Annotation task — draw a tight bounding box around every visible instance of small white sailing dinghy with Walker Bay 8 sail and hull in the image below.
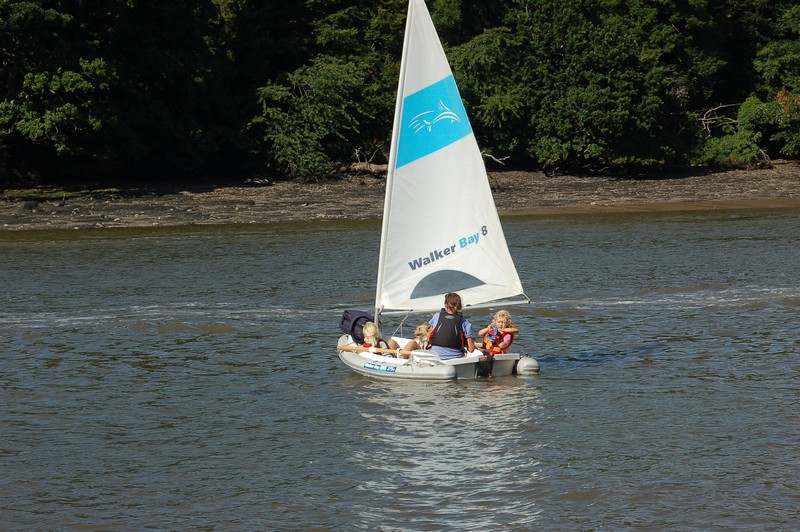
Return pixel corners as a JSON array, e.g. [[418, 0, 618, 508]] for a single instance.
[[337, 0, 538, 380]]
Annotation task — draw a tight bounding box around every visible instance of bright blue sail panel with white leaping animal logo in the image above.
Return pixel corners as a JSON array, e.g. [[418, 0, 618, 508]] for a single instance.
[[396, 75, 472, 168]]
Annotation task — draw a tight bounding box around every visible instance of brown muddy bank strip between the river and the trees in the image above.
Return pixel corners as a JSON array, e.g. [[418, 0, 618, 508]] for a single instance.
[[0, 161, 800, 231]]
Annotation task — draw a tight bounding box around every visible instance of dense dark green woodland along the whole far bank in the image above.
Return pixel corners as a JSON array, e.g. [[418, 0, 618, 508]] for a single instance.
[[0, 0, 800, 182]]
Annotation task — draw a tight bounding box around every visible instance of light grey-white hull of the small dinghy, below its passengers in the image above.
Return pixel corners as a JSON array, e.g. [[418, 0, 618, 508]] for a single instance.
[[337, 334, 539, 381]]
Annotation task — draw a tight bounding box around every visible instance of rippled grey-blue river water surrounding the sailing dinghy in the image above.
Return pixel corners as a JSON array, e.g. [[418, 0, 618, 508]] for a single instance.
[[0, 209, 800, 530]]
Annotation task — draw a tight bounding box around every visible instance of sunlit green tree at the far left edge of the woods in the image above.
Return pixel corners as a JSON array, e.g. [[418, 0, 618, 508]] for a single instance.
[[0, 2, 116, 180]]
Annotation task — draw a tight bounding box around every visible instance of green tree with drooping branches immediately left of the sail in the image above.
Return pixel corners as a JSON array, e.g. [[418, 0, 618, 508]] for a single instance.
[[249, 0, 405, 177]]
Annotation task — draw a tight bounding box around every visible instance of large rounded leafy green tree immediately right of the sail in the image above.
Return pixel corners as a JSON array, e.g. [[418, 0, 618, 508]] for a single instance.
[[453, 0, 688, 166]]
